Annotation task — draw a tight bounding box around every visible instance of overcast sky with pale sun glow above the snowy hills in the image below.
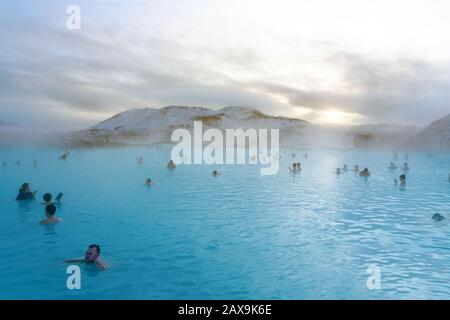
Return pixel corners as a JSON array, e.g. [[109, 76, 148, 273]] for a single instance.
[[0, 0, 450, 129]]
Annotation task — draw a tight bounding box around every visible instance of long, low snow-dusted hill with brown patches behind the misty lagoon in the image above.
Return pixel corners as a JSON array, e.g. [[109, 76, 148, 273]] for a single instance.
[[68, 106, 309, 144]]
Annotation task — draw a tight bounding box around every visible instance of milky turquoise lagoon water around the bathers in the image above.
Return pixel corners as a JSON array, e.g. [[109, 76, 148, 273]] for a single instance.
[[0, 146, 450, 299]]
